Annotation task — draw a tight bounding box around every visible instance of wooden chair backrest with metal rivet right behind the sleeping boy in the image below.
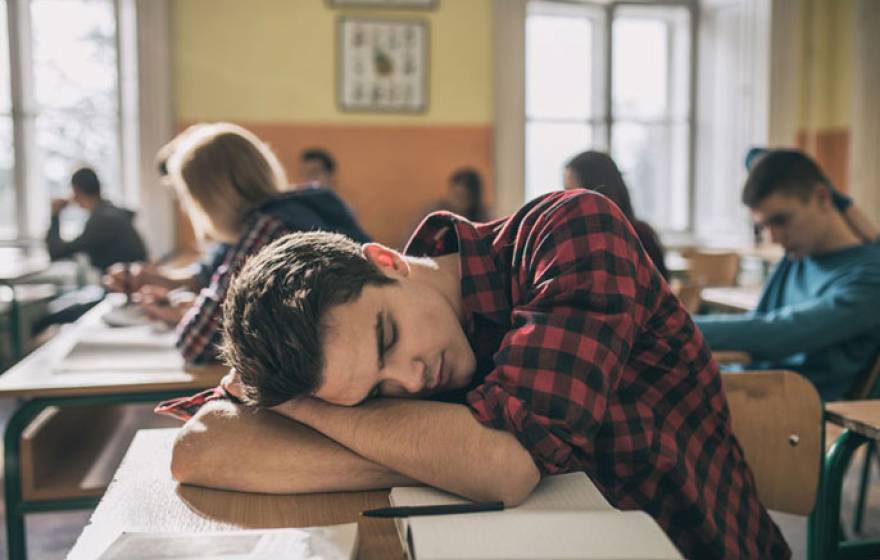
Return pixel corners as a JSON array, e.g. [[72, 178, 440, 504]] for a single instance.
[[721, 371, 823, 515]]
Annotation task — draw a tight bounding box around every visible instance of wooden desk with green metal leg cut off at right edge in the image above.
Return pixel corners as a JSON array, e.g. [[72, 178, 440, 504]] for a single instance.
[[817, 400, 880, 559]]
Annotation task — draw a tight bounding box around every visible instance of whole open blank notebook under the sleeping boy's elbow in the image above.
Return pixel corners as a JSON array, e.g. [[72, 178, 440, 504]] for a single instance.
[[390, 472, 682, 560]]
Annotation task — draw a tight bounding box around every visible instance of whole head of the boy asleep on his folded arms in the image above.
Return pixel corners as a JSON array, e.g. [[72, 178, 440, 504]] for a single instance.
[[223, 232, 475, 406]]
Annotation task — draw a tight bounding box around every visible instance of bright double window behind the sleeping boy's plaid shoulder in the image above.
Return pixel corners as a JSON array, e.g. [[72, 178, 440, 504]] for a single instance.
[[526, 1, 693, 232]]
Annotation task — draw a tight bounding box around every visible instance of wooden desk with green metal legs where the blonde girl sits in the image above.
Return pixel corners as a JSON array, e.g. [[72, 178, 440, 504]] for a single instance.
[[0, 301, 226, 560]]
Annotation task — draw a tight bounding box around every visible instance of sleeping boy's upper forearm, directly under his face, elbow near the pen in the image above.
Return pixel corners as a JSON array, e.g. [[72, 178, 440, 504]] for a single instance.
[[277, 399, 540, 505]]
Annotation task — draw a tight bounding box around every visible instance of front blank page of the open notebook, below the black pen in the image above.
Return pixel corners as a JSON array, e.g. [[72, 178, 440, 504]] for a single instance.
[[409, 510, 682, 560]]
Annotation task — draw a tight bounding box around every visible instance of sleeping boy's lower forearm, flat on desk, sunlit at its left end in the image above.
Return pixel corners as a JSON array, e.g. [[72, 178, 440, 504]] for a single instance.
[[171, 401, 413, 494]]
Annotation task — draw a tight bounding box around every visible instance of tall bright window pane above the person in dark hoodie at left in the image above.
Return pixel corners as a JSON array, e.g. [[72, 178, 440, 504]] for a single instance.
[[31, 0, 122, 221]]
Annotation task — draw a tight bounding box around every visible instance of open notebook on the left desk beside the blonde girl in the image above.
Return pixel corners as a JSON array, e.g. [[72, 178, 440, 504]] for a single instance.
[[54, 326, 184, 372]]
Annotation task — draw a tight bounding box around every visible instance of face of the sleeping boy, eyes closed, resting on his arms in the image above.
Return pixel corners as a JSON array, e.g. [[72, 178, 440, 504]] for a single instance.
[[314, 271, 476, 406]]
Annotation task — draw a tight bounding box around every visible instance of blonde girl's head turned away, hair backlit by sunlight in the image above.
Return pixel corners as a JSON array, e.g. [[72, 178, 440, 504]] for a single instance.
[[167, 123, 287, 242]]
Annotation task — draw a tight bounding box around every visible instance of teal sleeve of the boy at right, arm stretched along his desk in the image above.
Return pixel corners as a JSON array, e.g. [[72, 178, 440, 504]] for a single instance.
[[694, 273, 880, 360]]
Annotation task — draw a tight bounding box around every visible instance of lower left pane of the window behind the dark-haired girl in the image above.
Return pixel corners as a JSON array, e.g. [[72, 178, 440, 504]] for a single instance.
[[526, 121, 593, 200]]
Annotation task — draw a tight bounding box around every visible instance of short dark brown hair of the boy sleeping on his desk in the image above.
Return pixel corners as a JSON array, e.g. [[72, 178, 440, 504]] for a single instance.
[[221, 231, 395, 407]]
